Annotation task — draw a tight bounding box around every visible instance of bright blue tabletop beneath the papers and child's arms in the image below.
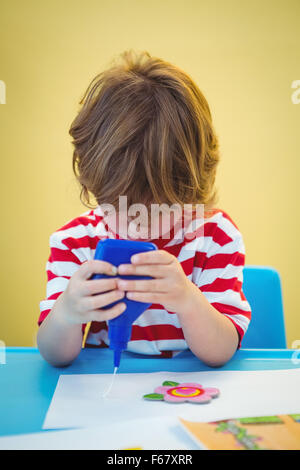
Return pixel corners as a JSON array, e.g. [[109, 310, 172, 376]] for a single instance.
[[0, 348, 300, 435]]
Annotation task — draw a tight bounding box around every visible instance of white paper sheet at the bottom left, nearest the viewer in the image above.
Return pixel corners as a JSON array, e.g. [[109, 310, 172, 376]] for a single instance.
[[0, 417, 199, 450]]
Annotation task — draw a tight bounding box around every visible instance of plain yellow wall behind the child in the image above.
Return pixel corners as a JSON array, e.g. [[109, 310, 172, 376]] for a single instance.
[[0, 0, 300, 346]]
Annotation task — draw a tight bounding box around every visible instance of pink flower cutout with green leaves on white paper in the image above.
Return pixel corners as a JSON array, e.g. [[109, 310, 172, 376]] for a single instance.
[[143, 381, 220, 403]]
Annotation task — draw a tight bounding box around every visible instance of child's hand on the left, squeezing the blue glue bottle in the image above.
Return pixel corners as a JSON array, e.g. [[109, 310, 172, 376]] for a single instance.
[[59, 259, 126, 324]]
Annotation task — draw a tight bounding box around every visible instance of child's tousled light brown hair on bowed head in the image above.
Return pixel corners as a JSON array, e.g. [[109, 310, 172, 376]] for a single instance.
[[69, 49, 219, 209]]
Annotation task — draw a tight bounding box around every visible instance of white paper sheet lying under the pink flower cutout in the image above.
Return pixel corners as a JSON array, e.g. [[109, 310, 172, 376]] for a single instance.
[[43, 369, 300, 432]]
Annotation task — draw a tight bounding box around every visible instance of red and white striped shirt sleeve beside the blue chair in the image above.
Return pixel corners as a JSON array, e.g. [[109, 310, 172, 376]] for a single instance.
[[192, 215, 251, 348]]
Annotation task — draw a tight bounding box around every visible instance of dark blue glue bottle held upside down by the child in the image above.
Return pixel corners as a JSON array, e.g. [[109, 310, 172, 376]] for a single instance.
[[90, 238, 157, 372]]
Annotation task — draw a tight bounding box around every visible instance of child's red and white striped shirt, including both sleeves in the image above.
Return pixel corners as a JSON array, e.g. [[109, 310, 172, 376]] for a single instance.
[[38, 206, 251, 356]]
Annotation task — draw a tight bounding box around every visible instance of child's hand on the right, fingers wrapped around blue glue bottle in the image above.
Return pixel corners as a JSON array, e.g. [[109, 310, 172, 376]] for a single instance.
[[117, 250, 194, 313]]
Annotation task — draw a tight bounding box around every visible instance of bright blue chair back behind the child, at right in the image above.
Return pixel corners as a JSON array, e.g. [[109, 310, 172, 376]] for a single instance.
[[241, 265, 286, 349]]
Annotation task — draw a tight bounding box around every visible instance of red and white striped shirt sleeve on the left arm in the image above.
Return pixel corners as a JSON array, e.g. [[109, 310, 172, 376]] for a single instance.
[[38, 231, 81, 326]]
